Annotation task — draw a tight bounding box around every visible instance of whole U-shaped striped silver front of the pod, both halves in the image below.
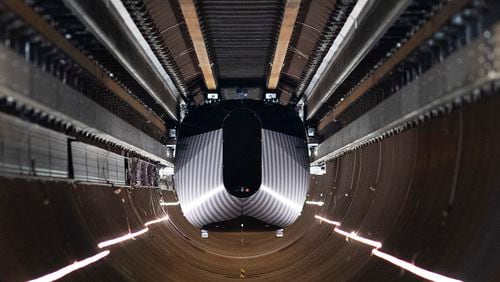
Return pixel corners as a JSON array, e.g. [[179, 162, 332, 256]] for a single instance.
[[175, 129, 309, 227]]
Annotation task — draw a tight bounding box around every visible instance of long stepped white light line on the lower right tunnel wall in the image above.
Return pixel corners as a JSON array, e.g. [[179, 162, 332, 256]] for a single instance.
[[314, 215, 463, 282]]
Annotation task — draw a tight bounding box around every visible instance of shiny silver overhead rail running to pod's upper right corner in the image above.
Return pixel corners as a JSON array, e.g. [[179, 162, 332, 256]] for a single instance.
[[305, 0, 412, 119]]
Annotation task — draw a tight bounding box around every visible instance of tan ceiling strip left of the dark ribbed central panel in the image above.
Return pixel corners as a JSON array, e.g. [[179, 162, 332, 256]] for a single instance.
[[179, 0, 217, 90]]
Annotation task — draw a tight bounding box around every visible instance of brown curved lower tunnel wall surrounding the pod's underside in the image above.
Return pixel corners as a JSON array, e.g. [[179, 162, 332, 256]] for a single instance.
[[0, 97, 500, 281]]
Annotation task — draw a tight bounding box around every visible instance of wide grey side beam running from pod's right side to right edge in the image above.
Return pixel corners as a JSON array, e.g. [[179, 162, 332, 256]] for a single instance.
[[313, 24, 500, 164]]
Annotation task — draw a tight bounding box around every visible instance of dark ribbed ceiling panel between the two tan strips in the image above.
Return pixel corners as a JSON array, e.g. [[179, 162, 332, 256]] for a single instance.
[[197, 0, 283, 87]]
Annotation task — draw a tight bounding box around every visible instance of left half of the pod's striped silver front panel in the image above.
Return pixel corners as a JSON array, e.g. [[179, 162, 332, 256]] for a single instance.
[[175, 129, 241, 227]]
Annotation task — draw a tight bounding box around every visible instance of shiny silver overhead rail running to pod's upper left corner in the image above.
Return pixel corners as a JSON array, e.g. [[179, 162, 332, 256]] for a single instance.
[[63, 0, 179, 120]]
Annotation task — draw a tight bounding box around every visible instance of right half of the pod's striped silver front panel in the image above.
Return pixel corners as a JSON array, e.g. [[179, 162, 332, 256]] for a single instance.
[[243, 129, 309, 226]]
